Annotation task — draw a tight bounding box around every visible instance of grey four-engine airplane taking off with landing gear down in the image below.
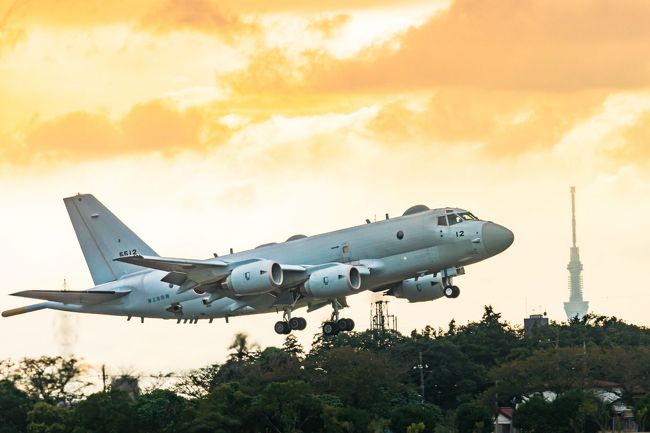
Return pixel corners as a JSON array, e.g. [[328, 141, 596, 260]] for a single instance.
[[2, 194, 514, 336]]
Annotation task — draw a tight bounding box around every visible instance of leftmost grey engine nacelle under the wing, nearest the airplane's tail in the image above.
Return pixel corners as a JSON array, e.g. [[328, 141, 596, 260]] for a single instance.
[[226, 260, 284, 295]]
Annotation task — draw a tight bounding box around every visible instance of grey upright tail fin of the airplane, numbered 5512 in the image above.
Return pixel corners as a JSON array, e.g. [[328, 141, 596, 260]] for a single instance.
[[63, 194, 158, 285]]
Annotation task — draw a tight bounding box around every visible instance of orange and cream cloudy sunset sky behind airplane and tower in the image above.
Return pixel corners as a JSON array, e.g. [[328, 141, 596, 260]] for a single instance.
[[0, 0, 650, 372]]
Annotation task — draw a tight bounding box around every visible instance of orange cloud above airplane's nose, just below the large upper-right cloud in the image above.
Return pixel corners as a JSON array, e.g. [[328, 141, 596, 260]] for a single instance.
[[367, 89, 605, 158]]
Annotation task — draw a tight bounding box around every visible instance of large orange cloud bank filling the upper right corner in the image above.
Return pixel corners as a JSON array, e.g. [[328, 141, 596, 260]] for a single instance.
[[220, 0, 650, 93]]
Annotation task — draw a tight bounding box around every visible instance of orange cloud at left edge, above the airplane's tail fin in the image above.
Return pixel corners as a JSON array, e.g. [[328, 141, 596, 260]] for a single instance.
[[0, 100, 232, 165]]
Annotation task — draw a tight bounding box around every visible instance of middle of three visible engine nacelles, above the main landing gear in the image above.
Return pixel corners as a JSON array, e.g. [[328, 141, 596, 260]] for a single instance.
[[305, 264, 361, 298]]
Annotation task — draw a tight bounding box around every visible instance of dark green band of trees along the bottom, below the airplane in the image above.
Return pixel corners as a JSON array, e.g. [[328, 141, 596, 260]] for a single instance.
[[0, 306, 650, 433]]
